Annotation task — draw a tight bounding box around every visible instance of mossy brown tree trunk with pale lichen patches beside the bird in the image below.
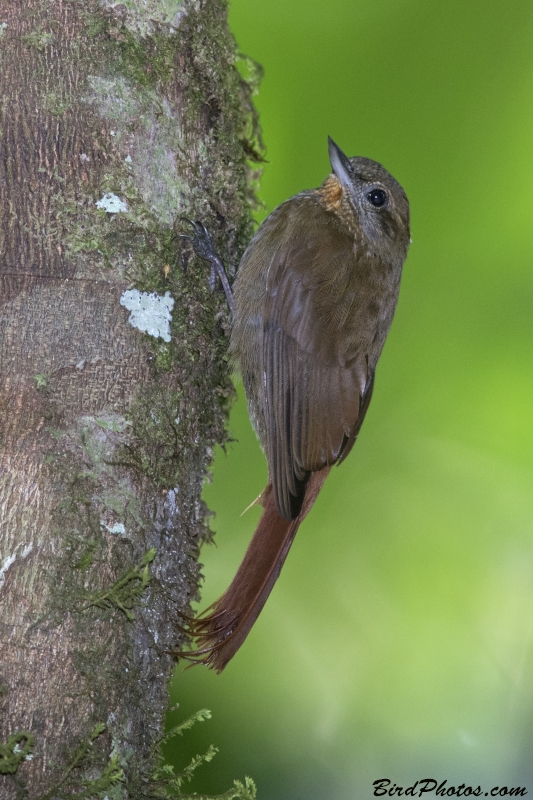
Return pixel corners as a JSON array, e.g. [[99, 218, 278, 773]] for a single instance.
[[0, 0, 257, 800]]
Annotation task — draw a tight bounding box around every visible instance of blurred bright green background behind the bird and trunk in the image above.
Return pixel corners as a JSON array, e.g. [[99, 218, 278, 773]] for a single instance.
[[168, 0, 533, 800]]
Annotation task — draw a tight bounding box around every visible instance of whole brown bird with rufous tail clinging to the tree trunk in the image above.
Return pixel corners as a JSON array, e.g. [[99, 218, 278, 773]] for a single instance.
[[178, 137, 410, 672]]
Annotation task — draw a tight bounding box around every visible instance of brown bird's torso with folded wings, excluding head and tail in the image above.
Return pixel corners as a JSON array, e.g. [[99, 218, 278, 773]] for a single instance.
[[231, 198, 388, 520]]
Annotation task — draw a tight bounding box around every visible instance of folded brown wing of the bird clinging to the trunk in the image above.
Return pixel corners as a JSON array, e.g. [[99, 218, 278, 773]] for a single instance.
[[261, 203, 373, 519]]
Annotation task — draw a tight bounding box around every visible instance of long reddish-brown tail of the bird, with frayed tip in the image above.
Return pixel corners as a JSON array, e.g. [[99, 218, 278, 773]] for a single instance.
[[175, 467, 330, 672]]
